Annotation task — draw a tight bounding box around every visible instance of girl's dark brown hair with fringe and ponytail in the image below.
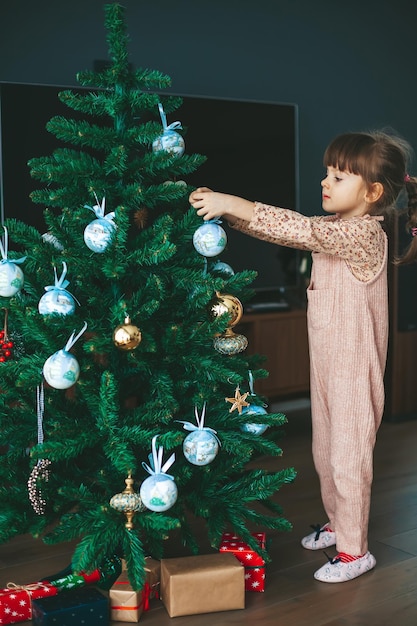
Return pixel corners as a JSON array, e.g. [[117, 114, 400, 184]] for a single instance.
[[323, 131, 417, 264]]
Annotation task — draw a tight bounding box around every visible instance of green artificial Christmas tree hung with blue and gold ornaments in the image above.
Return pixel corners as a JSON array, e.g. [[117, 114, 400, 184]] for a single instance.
[[0, 4, 295, 589]]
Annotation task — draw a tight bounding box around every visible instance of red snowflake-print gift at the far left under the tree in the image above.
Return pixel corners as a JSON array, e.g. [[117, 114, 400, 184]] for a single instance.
[[0, 582, 58, 624]]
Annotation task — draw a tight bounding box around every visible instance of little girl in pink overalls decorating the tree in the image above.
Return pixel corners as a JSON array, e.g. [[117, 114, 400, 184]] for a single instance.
[[190, 132, 417, 583]]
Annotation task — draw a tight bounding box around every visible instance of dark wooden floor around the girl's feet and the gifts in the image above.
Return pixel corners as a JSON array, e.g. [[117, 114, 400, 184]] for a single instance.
[[0, 400, 417, 626]]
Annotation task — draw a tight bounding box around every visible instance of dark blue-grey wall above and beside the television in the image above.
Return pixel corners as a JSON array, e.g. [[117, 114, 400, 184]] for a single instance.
[[0, 0, 417, 214]]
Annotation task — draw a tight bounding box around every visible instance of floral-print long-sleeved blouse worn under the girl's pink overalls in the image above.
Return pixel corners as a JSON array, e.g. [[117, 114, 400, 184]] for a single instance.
[[229, 202, 386, 281]]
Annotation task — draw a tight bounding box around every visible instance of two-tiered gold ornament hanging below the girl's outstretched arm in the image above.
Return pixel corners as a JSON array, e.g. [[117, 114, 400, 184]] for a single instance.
[[211, 291, 248, 356]]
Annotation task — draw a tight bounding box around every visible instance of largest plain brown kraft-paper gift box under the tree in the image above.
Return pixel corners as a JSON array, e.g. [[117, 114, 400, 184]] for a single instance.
[[161, 553, 245, 617]]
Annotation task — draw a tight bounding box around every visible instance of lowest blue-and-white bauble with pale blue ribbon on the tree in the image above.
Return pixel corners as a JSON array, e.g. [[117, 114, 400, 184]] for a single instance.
[[140, 435, 178, 513]]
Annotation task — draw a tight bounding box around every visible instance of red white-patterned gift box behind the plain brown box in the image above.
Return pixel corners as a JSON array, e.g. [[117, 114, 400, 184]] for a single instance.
[[219, 533, 266, 592]]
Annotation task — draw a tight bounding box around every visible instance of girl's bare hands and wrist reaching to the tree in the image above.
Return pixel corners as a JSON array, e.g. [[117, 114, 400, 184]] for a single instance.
[[189, 187, 254, 222]]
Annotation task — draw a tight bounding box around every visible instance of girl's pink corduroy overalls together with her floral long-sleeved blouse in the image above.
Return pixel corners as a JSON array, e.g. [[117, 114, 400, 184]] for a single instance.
[[234, 203, 388, 556]]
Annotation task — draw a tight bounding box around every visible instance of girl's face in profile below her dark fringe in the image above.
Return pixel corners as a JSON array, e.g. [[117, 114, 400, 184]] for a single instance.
[[321, 167, 371, 219]]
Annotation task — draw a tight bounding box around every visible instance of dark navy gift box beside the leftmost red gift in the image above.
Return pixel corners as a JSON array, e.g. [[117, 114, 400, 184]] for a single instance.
[[32, 587, 109, 626]]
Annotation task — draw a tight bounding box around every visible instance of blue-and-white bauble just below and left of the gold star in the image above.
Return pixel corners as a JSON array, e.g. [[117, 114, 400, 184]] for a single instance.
[[178, 405, 220, 465]]
